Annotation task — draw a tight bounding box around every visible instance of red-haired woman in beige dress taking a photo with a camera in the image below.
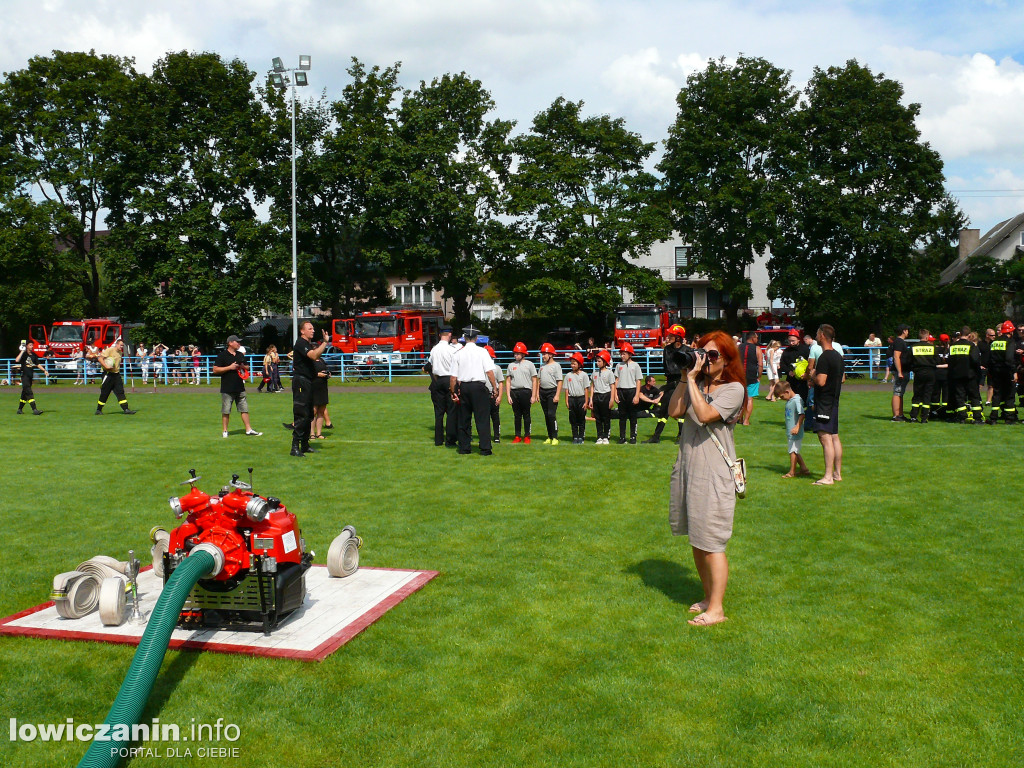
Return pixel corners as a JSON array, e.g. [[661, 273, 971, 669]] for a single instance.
[[669, 331, 746, 627]]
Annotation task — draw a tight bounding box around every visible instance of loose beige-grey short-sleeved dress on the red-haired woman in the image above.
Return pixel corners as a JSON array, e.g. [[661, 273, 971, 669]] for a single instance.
[[669, 380, 744, 552]]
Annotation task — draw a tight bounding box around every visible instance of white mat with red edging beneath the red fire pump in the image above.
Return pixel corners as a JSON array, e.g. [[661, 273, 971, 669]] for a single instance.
[[0, 565, 437, 662]]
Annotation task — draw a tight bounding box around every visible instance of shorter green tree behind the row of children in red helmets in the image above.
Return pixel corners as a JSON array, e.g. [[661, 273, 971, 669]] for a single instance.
[[493, 97, 671, 330]]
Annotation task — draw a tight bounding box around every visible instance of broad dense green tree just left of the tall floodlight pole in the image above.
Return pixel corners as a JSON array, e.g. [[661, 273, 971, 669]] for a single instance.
[[103, 51, 291, 344]]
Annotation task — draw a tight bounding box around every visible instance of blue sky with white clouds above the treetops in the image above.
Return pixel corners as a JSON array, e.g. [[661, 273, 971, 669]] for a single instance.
[[0, 0, 1024, 230]]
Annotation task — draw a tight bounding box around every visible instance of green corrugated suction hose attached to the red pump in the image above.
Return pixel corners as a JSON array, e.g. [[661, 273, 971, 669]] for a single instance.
[[78, 545, 220, 768]]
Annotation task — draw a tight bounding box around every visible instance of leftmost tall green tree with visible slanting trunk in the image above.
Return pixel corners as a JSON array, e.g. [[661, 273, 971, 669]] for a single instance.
[[0, 51, 136, 314]]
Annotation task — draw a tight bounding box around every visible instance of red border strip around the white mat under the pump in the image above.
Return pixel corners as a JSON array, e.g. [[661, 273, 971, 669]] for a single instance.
[[0, 565, 439, 662]]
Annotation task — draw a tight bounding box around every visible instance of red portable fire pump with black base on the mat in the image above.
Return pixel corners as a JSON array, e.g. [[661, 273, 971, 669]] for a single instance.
[[152, 469, 311, 634]]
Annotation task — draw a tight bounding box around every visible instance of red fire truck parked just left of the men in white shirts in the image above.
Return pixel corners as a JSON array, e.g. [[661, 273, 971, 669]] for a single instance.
[[352, 306, 444, 368]]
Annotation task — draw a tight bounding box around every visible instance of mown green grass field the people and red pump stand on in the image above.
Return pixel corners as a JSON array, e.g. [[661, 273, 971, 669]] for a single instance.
[[0, 386, 1024, 768]]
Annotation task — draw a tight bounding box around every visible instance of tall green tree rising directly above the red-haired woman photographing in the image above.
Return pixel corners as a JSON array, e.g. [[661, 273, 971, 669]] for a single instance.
[[658, 56, 799, 328]]
